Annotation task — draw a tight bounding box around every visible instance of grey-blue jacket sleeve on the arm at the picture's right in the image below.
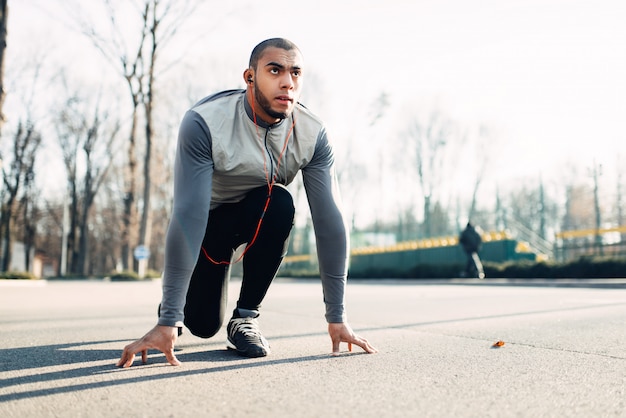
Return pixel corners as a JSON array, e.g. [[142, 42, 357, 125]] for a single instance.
[[302, 130, 349, 323]]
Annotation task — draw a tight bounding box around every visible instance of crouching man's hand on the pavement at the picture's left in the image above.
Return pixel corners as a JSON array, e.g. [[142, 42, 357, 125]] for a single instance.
[[117, 325, 181, 367]]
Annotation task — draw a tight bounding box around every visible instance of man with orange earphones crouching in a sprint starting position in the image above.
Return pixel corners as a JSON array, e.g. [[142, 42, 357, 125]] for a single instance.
[[117, 38, 377, 367]]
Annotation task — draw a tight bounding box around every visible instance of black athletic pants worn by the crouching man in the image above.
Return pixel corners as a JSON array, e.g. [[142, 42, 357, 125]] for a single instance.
[[184, 185, 295, 338]]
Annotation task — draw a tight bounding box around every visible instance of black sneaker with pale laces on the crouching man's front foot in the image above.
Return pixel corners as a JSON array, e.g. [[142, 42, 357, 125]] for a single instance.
[[226, 317, 270, 357]]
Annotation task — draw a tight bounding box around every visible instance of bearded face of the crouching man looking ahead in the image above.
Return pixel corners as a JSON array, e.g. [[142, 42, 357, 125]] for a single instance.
[[249, 47, 302, 123]]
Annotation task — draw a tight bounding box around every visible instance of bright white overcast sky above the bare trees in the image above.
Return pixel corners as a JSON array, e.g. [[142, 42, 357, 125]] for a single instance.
[[7, 0, 626, 217]]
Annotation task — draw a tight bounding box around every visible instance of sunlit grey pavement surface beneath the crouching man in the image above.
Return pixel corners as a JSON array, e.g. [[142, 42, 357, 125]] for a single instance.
[[0, 279, 626, 417]]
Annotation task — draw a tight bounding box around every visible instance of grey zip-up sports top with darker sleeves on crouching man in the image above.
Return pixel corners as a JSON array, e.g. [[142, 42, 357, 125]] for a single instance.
[[158, 90, 349, 326]]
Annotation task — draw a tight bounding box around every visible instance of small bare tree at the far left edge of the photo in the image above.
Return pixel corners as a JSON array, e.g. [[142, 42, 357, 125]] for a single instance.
[[0, 121, 41, 271]]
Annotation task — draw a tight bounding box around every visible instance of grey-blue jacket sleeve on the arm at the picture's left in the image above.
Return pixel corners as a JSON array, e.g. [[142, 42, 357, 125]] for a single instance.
[[158, 110, 213, 326]]
